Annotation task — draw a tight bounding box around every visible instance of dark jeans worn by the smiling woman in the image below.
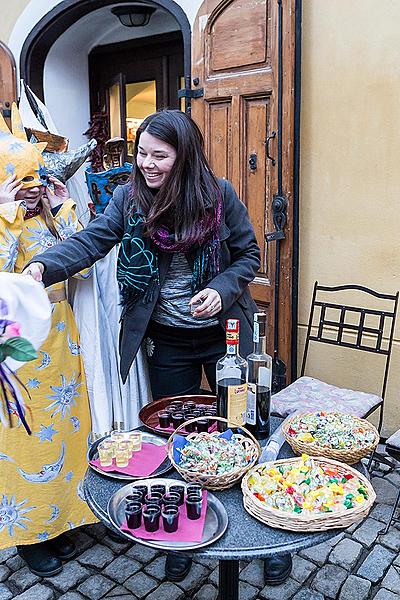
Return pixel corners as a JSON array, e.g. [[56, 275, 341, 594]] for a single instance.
[[145, 321, 226, 400]]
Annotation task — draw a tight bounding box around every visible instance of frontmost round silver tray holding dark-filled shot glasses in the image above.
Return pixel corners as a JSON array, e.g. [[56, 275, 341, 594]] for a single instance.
[[107, 478, 228, 550]]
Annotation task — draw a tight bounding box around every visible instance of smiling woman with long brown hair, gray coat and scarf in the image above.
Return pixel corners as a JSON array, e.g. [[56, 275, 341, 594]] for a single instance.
[[27, 110, 290, 581]]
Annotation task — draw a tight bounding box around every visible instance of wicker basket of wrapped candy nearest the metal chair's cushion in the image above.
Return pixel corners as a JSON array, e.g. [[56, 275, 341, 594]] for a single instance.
[[282, 411, 379, 465]]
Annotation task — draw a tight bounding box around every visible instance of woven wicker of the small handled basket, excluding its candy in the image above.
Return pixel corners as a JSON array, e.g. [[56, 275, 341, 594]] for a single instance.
[[167, 417, 261, 490]]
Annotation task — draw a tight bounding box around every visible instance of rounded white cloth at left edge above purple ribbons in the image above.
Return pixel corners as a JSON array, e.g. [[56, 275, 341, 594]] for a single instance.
[[0, 273, 51, 371]]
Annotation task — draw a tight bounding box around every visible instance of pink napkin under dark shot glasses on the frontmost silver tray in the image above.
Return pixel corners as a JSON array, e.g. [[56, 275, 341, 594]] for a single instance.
[[121, 490, 207, 542]]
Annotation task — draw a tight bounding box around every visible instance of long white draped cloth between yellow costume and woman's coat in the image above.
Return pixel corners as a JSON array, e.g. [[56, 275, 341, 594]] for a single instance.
[[69, 248, 151, 436]]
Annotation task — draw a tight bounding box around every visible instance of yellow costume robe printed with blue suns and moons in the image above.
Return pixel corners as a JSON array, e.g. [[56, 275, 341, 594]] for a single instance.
[[0, 200, 96, 549]]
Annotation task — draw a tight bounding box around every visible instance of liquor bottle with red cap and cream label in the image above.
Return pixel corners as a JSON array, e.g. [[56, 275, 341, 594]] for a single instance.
[[216, 319, 247, 430]]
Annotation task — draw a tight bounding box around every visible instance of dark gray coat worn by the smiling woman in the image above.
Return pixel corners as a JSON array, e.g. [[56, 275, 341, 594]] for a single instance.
[[31, 179, 260, 381]]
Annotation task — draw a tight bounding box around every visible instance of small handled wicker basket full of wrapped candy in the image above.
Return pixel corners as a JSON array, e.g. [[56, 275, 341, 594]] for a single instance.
[[167, 416, 261, 490]]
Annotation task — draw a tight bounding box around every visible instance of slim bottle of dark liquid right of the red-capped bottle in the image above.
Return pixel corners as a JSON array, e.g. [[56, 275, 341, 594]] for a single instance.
[[246, 313, 272, 439]]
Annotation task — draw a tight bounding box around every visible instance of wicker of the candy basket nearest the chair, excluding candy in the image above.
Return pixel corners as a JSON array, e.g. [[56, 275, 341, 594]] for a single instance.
[[282, 411, 379, 465]]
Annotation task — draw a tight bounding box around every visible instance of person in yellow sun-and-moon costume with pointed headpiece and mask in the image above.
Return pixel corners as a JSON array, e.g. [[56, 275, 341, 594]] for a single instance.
[[0, 105, 96, 577]]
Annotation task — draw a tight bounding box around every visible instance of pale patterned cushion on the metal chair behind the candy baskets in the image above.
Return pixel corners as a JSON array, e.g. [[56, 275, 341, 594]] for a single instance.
[[271, 377, 382, 417]]
